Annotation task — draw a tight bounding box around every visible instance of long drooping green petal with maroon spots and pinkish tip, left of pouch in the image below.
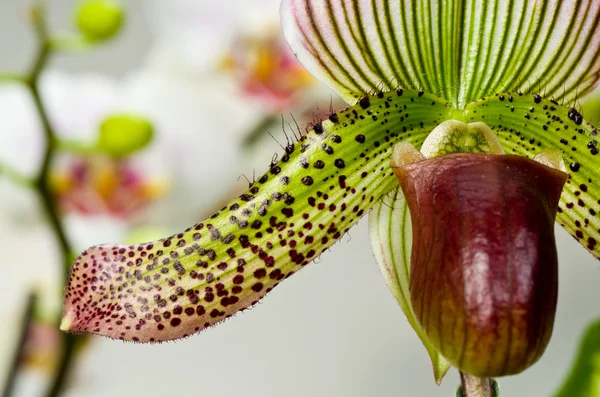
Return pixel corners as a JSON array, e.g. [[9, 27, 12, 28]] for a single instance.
[[61, 91, 451, 342]]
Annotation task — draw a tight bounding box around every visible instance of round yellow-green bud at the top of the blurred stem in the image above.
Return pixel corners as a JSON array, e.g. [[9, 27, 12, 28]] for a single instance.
[[75, 0, 124, 42]]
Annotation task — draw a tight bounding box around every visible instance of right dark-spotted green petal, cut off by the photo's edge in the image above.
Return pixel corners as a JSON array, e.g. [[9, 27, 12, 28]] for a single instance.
[[466, 94, 600, 258]]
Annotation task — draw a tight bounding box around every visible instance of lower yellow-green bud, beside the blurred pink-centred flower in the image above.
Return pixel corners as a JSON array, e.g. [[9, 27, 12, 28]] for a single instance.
[[98, 114, 154, 157]]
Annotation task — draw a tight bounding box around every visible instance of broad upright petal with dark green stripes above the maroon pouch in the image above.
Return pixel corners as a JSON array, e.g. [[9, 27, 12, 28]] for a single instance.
[[282, 0, 600, 109]]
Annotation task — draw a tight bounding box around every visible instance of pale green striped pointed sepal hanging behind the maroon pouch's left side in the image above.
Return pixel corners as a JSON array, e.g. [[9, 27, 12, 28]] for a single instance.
[[369, 186, 450, 384]]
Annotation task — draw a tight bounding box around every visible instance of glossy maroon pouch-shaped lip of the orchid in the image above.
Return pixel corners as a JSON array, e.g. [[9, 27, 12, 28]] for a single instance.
[[394, 154, 567, 377]]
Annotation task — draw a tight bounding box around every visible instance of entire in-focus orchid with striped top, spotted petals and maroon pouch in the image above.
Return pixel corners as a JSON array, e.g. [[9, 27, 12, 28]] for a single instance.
[[61, 0, 600, 390]]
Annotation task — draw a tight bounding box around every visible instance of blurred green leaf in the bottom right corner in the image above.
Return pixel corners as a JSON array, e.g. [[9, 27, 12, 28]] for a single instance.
[[554, 321, 600, 397]]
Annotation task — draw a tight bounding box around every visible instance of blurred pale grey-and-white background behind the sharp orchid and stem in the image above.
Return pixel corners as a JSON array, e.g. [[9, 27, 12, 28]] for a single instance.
[[0, 0, 600, 397]]
